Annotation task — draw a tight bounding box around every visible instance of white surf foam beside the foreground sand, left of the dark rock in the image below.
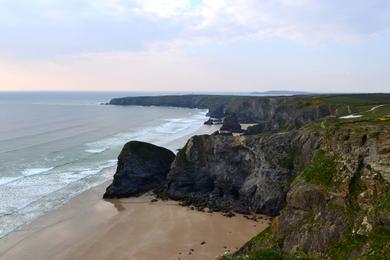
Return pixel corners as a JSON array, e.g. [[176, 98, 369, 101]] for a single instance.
[[0, 157, 117, 238]]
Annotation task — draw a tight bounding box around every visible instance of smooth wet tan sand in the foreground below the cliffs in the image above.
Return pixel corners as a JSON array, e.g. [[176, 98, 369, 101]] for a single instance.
[[0, 184, 269, 260]]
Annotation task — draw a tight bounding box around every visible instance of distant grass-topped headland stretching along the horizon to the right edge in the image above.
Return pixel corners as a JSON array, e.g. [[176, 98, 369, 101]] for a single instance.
[[110, 94, 390, 134]]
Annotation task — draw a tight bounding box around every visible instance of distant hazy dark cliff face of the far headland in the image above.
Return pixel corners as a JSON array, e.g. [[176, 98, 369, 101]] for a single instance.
[[110, 95, 336, 131]]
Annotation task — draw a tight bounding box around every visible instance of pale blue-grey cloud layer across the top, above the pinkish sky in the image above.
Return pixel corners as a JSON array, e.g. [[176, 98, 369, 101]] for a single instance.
[[0, 0, 390, 57]]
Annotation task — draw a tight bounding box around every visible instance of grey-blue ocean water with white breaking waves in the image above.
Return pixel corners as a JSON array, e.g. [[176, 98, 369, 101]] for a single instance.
[[0, 92, 207, 238]]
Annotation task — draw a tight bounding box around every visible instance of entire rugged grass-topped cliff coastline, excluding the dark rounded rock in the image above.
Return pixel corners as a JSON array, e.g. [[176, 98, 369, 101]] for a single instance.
[[106, 94, 390, 259]]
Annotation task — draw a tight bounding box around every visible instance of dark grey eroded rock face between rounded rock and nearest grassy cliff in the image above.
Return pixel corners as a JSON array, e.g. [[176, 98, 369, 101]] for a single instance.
[[166, 131, 321, 215]]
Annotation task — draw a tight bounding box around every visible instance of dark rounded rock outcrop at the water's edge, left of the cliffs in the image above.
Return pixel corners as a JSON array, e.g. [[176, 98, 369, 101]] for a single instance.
[[103, 141, 175, 198]]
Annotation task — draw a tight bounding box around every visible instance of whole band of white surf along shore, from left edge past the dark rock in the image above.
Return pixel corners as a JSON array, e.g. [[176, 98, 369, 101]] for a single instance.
[[0, 110, 210, 238]]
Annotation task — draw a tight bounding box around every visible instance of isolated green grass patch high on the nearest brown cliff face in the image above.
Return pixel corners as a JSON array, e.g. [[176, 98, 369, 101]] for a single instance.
[[301, 150, 336, 187]]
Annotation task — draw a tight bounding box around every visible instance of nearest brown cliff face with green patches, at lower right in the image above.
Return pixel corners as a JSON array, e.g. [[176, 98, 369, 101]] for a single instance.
[[232, 124, 390, 259]]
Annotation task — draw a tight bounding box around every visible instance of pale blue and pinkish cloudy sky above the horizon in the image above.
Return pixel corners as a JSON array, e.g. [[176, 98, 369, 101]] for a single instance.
[[0, 0, 390, 92]]
